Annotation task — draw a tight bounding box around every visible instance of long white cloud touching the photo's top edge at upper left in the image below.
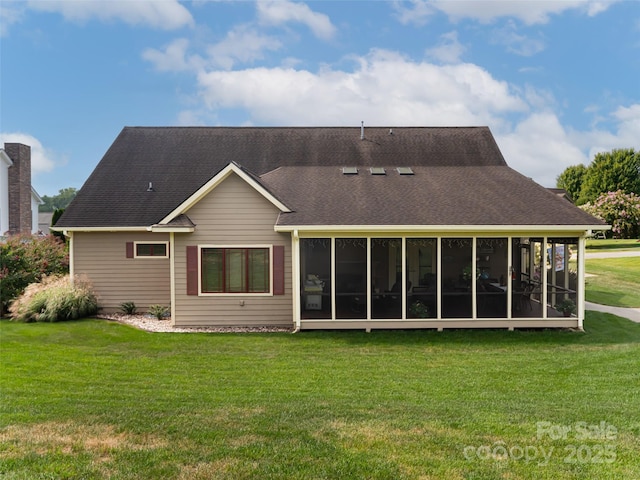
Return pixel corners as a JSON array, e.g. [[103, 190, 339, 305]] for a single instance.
[[28, 0, 195, 30]]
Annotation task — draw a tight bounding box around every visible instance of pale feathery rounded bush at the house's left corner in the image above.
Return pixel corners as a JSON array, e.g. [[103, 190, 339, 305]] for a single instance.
[[9, 275, 98, 322]]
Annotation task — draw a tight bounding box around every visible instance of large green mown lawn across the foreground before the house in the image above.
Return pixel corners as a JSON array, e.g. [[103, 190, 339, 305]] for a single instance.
[[0, 312, 640, 480]]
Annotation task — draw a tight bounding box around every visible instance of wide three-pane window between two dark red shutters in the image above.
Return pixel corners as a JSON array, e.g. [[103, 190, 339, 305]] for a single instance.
[[201, 247, 270, 293]]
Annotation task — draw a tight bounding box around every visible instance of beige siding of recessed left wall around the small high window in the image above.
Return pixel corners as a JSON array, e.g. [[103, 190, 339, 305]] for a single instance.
[[73, 232, 171, 312]]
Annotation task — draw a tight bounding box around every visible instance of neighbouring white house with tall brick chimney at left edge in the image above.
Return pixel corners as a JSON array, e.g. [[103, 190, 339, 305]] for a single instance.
[[0, 143, 43, 235]]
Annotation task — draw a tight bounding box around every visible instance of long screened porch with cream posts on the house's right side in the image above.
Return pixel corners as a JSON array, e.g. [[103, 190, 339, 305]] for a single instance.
[[296, 235, 584, 329]]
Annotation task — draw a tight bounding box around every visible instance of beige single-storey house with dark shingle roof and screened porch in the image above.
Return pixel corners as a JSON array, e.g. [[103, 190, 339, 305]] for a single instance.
[[54, 127, 607, 330]]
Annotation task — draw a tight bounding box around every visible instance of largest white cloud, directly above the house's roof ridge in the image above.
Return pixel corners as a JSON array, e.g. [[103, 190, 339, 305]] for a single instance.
[[198, 50, 527, 125]]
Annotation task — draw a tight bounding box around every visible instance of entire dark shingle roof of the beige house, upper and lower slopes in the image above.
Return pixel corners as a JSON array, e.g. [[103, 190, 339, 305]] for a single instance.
[[56, 127, 604, 228]]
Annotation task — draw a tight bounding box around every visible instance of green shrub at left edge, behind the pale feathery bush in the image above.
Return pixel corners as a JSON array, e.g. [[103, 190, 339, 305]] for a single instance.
[[0, 235, 69, 316]]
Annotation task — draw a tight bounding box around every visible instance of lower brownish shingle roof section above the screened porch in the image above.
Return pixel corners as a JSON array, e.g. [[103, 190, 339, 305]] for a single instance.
[[261, 165, 601, 226]]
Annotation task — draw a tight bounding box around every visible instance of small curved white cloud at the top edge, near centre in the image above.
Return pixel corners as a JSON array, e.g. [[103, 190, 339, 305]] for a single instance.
[[257, 0, 336, 40]]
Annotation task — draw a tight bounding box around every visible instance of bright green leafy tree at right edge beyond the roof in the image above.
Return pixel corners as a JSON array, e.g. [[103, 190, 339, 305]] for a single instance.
[[578, 148, 640, 204]]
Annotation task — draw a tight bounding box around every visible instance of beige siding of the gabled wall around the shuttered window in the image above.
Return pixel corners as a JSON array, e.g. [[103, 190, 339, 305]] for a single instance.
[[174, 174, 293, 326]]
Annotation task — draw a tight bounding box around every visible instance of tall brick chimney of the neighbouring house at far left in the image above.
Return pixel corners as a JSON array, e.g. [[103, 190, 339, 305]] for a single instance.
[[4, 143, 32, 234]]
